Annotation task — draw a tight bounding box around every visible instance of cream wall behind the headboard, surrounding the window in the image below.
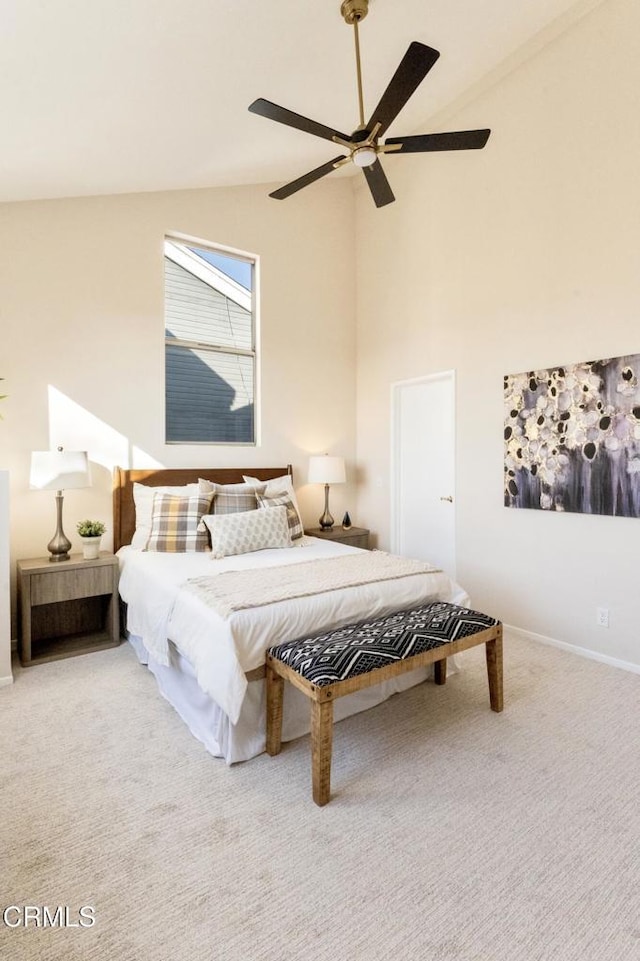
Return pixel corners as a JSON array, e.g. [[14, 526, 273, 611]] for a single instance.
[[0, 179, 355, 632]]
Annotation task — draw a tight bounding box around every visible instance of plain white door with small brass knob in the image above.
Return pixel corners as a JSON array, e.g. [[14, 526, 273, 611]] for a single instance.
[[391, 371, 456, 579]]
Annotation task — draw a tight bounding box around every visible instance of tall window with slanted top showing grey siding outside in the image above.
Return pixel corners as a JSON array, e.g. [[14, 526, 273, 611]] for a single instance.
[[164, 238, 256, 444]]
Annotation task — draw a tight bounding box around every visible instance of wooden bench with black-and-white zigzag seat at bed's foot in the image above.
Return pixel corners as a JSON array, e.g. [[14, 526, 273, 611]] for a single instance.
[[266, 601, 503, 806]]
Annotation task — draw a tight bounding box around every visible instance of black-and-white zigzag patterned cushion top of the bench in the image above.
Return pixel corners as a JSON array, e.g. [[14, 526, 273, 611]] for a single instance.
[[269, 601, 499, 687]]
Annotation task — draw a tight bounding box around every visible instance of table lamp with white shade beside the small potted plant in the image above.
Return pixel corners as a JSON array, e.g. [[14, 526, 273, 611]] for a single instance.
[[29, 447, 91, 561]]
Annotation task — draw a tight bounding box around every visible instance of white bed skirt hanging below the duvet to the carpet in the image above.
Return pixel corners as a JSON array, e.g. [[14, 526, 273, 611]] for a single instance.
[[129, 635, 457, 764]]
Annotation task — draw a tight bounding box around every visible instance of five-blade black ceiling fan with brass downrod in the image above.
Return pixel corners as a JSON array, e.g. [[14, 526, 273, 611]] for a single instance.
[[249, 0, 491, 207]]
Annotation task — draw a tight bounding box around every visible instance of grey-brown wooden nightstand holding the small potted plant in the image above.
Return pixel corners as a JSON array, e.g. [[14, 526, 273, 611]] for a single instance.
[[18, 552, 120, 667]]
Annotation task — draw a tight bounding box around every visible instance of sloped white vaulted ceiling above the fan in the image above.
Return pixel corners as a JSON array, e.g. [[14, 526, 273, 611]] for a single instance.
[[0, 0, 602, 201]]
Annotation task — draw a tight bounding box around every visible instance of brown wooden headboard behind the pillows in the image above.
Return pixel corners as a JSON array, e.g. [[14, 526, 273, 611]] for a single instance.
[[113, 464, 293, 553]]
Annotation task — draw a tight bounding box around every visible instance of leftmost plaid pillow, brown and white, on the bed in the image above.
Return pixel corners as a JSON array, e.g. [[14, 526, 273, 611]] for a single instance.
[[146, 494, 212, 553]]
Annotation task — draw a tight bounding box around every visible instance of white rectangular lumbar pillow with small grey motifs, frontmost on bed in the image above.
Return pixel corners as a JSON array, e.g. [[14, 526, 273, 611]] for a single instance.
[[203, 506, 291, 558]]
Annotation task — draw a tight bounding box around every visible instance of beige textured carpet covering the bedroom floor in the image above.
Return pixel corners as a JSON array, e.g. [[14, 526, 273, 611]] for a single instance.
[[0, 640, 640, 961]]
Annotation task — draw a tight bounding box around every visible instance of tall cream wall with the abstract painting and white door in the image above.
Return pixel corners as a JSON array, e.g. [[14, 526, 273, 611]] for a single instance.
[[356, 0, 640, 665]]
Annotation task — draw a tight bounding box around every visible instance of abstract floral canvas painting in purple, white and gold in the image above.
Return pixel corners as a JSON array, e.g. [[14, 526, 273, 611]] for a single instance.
[[504, 354, 640, 517]]
